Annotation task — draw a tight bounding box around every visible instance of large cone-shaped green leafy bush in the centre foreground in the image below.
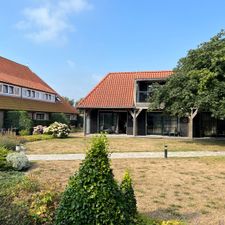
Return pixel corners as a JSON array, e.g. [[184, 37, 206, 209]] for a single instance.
[[56, 135, 137, 225]]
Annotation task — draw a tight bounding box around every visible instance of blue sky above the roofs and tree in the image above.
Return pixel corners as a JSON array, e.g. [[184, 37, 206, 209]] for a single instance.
[[0, 0, 225, 100]]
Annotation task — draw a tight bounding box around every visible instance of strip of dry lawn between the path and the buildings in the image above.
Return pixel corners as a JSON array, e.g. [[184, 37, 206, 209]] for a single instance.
[[26, 133, 225, 154]]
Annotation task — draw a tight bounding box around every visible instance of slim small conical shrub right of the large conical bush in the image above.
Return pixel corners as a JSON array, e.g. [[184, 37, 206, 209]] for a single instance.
[[120, 172, 137, 224]]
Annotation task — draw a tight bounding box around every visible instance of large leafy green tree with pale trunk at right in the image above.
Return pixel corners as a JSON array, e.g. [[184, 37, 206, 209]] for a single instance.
[[149, 30, 225, 137]]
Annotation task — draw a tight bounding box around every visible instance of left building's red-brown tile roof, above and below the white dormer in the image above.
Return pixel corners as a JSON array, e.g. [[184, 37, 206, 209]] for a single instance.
[[0, 56, 77, 114]]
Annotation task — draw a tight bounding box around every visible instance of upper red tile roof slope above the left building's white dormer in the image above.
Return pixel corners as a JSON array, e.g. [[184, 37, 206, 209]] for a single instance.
[[0, 57, 56, 94]]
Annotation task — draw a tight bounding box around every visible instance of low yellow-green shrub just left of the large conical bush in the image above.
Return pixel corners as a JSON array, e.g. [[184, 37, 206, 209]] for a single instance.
[[29, 191, 59, 225]]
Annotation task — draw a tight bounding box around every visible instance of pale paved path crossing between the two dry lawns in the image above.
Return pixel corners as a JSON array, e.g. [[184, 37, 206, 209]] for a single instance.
[[27, 151, 225, 161]]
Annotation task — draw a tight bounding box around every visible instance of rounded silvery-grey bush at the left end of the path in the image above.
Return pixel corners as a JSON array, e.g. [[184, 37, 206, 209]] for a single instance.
[[6, 152, 30, 170]]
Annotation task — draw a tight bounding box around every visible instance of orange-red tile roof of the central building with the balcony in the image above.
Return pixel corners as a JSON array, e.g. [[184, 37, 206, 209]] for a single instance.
[[78, 71, 173, 108]]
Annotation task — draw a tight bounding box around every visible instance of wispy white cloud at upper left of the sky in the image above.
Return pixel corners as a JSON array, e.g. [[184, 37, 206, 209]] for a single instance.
[[17, 0, 92, 43]]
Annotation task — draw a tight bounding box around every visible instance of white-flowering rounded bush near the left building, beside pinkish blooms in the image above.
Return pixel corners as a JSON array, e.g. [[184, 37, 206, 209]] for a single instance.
[[44, 122, 70, 138]]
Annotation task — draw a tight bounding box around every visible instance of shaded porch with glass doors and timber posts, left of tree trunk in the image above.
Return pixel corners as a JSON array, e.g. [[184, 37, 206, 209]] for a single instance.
[[81, 109, 188, 137]]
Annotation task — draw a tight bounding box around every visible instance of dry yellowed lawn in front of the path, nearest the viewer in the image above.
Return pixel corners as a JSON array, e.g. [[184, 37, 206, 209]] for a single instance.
[[28, 157, 225, 225]]
